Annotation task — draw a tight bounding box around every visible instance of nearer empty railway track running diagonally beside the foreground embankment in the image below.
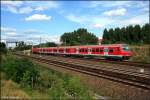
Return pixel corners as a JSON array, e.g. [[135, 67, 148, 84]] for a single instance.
[[13, 54, 150, 89]]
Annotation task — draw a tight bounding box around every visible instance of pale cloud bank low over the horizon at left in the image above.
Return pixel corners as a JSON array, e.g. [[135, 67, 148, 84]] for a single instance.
[[1, 27, 60, 44]]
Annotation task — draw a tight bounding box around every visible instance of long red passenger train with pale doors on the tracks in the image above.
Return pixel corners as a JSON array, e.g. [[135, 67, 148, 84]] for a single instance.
[[32, 44, 131, 60]]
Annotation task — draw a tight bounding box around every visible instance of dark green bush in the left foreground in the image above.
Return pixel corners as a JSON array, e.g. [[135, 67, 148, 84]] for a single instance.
[[3, 56, 38, 87]]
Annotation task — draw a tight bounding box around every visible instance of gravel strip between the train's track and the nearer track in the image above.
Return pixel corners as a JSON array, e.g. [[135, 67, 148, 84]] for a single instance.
[[32, 54, 150, 76]]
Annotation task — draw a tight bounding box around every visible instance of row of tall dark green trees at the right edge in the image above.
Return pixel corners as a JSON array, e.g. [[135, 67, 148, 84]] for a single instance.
[[102, 23, 150, 44]]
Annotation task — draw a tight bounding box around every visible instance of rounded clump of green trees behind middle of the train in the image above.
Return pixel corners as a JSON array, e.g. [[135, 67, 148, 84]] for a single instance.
[[60, 28, 98, 46]]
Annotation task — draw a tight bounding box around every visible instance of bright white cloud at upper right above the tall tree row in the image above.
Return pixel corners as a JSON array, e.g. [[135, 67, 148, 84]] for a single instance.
[[104, 8, 126, 16]]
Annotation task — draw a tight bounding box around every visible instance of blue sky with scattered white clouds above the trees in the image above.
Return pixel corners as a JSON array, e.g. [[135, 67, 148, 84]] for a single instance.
[[1, 1, 149, 43]]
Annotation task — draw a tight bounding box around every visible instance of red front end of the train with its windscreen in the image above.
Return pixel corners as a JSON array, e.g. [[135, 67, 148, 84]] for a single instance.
[[121, 44, 132, 60]]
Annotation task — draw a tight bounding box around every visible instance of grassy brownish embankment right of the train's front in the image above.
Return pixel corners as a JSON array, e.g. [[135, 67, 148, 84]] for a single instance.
[[129, 45, 150, 63]]
